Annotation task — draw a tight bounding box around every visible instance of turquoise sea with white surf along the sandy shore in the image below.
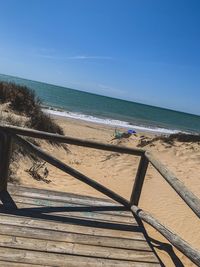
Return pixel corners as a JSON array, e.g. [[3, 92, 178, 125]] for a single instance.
[[0, 74, 200, 134]]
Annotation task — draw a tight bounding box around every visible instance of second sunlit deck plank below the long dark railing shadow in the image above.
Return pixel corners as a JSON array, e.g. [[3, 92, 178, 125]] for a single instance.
[[0, 224, 152, 251]]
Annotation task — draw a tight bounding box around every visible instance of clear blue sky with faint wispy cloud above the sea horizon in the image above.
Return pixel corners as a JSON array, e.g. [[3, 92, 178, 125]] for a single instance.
[[0, 0, 200, 115]]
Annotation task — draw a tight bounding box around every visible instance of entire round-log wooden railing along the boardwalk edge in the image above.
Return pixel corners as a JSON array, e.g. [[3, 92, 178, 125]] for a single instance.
[[0, 126, 200, 266]]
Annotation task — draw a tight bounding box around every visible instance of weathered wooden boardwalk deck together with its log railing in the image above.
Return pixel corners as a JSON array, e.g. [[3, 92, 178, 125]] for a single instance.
[[0, 125, 200, 267]]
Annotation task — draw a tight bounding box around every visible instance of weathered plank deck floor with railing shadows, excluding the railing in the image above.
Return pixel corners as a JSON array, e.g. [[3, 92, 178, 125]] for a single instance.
[[0, 185, 160, 267]]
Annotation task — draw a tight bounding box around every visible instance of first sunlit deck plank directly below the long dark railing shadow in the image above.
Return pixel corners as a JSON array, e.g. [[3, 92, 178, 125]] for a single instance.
[[0, 213, 145, 240]]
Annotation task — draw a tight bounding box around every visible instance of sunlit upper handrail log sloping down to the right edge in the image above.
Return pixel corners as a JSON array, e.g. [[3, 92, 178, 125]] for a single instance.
[[145, 152, 200, 218]]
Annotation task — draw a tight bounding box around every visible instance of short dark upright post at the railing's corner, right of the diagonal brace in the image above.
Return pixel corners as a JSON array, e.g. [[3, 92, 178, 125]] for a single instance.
[[130, 155, 149, 205]]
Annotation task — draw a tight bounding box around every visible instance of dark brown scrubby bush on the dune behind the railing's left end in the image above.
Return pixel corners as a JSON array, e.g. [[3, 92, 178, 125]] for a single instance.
[[0, 82, 63, 135]]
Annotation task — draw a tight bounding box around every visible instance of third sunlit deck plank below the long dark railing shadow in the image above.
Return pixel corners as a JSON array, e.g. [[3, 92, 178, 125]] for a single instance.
[[0, 235, 157, 263]]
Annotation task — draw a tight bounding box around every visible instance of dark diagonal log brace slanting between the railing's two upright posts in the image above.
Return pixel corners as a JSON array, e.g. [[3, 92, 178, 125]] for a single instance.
[[13, 135, 129, 207]]
